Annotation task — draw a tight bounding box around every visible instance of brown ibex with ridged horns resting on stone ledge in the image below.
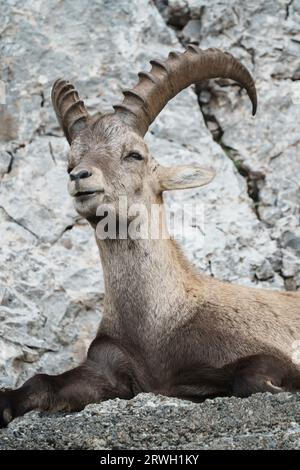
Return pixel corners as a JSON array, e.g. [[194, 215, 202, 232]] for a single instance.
[[0, 46, 300, 426]]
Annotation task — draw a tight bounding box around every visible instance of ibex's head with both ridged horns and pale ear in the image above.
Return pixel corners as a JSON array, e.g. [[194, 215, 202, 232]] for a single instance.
[[52, 46, 257, 223]]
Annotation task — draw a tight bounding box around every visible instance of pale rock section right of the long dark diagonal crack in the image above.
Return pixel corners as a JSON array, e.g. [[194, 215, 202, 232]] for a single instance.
[[157, 0, 300, 290]]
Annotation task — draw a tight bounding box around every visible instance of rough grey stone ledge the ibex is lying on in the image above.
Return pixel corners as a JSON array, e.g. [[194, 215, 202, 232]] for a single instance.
[[0, 394, 300, 450]]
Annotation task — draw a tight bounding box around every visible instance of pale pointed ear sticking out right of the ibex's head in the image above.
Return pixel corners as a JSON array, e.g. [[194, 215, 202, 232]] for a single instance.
[[157, 165, 215, 191]]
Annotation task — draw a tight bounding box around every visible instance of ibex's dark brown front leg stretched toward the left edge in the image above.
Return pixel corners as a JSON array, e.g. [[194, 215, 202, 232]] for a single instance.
[[0, 342, 133, 427]]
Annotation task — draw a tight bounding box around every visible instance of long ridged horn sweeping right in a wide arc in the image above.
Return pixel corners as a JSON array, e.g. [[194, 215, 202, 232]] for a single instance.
[[114, 45, 257, 136]]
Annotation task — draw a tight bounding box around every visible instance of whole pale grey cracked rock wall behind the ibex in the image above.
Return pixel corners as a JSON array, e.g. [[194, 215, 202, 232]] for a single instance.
[[0, 0, 300, 445]]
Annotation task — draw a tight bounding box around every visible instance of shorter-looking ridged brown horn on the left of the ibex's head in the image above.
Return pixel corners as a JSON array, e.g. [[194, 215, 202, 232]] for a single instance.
[[51, 78, 90, 145]]
